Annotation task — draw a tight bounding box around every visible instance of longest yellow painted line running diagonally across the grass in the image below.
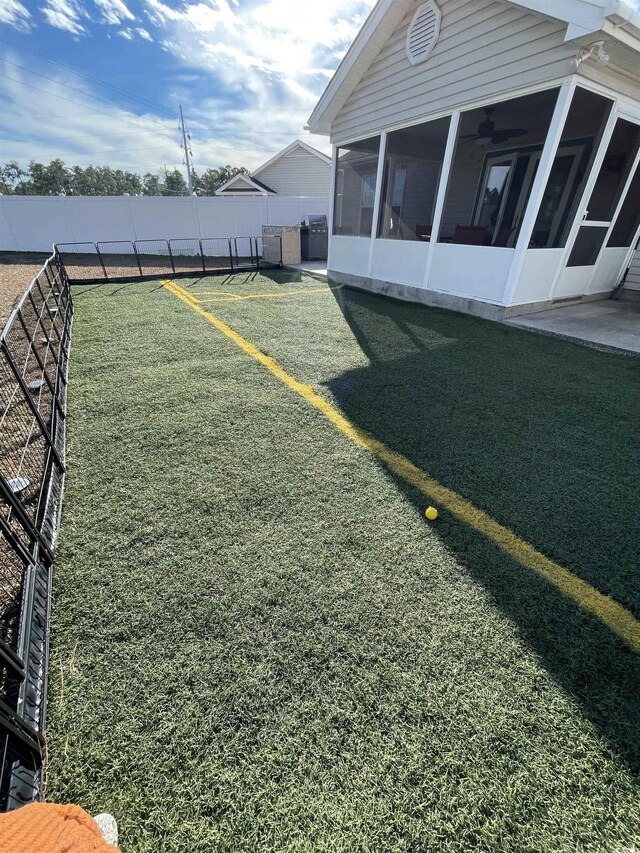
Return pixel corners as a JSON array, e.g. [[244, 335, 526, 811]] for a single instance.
[[164, 281, 640, 652]]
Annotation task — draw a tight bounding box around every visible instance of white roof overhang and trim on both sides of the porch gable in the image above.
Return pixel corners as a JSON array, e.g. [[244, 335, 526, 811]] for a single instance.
[[307, 0, 640, 134]]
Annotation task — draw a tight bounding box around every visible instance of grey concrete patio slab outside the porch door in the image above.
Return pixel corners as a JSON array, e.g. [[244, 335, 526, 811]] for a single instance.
[[505, 299, 640, 355]]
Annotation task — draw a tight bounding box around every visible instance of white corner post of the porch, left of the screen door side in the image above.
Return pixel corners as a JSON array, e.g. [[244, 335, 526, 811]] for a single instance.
[[502, 76, 576, 305]]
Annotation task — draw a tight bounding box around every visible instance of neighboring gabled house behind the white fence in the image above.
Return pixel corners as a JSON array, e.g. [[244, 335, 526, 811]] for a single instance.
[[216, 139, 331, 198]]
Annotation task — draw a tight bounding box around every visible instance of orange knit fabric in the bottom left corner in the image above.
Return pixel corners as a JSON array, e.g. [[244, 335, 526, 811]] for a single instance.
[[0, 803, 118, 853]]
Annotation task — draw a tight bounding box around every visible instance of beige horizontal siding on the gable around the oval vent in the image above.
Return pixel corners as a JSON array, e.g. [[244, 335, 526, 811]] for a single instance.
[[332, 0, 576, 141]]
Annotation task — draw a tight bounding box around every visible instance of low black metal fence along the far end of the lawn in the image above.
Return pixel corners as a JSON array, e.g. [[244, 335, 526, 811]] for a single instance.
[[55, 235, 282, 284]]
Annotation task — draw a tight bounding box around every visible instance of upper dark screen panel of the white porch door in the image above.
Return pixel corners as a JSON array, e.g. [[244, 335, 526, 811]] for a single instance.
[[586, 118, 640, 222]]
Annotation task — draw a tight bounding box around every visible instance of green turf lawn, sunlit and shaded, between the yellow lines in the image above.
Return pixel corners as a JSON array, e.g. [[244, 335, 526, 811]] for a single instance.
[[47, 272, 640, 853]]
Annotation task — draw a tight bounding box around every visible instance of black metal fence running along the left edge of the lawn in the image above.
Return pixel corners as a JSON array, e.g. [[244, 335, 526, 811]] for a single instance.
[[0, 255, 73, 809]]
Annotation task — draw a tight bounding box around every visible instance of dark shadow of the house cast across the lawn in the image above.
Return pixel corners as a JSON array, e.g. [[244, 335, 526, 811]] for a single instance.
[[327, 289, 640, 773]]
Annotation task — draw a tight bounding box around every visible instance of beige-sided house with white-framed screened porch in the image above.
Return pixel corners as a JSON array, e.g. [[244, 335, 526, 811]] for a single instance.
[[308, 0, 640, 319]]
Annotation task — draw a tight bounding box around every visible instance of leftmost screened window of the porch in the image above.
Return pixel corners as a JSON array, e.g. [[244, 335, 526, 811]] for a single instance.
[[333, 136, 380, 237]]
